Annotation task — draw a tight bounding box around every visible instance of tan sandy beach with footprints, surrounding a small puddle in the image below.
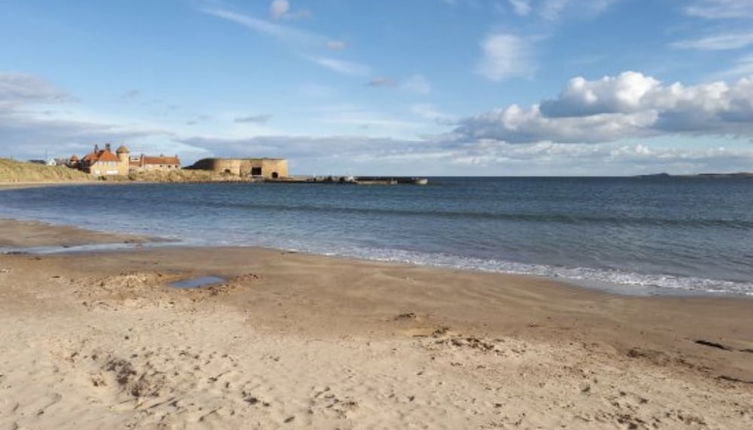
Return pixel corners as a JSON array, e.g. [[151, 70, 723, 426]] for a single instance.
[[0, 221, 753, 430]]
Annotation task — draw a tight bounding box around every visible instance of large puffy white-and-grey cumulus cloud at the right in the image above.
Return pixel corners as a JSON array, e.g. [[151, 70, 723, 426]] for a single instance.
[[455, 72, 753, 143]]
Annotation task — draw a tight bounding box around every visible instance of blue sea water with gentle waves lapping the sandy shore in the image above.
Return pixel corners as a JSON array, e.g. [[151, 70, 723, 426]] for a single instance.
[[0, 178, 753, 295]]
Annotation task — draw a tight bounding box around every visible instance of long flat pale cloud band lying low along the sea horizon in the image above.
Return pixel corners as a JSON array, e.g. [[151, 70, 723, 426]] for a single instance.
[[178, 135, 753, 175]]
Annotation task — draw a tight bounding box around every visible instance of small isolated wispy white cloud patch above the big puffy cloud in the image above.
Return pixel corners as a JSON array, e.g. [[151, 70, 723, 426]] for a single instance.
[[476, 33, 535, 82]]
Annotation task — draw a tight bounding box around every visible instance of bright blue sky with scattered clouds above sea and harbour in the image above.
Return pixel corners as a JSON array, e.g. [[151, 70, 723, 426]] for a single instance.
[[0, 0, 753, 176]]
